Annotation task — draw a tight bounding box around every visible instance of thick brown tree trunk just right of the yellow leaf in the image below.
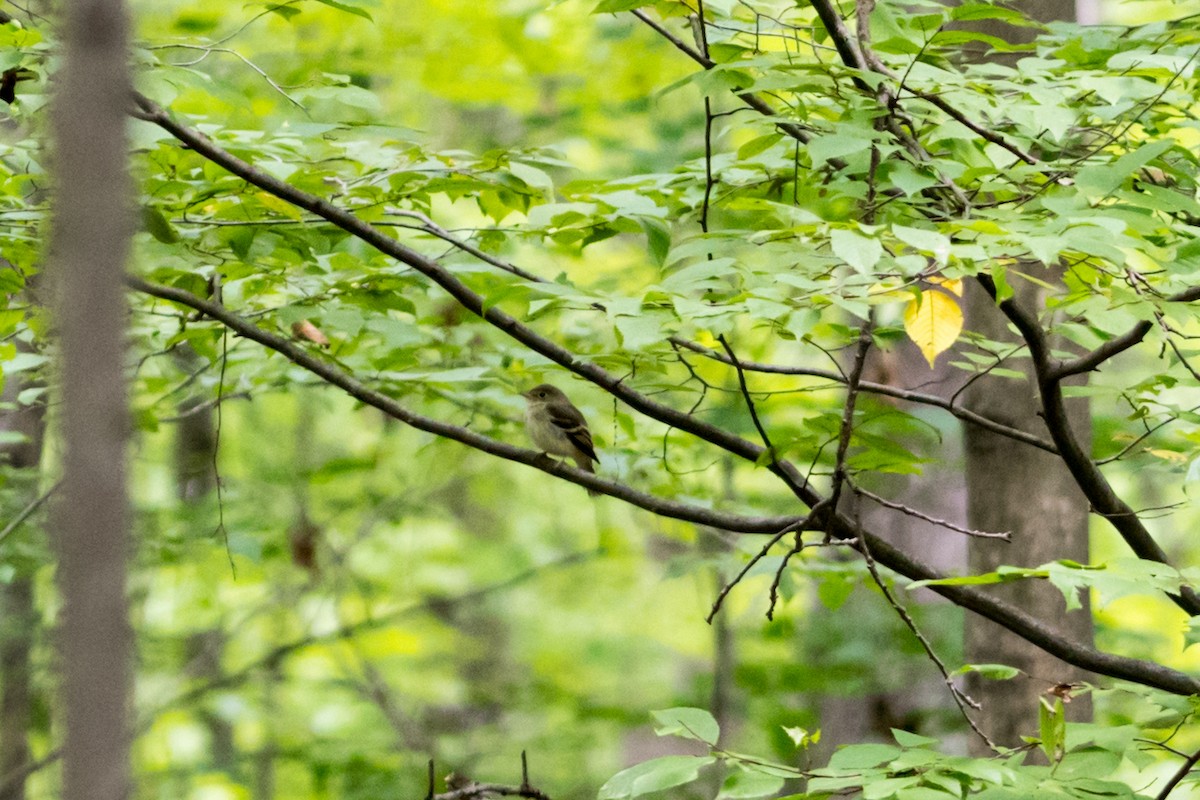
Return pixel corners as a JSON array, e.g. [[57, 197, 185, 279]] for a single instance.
[[966, 277, 1092, 753]]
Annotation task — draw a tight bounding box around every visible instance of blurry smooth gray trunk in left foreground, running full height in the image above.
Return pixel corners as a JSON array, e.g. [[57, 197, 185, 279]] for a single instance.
[[49, 0, 132, 800]]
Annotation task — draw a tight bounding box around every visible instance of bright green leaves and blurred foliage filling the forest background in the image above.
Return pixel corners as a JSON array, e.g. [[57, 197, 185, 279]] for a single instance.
[[0, 0, 1200, 800]]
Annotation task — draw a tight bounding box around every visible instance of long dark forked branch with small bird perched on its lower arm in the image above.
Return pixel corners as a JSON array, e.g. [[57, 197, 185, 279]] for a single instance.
[[130, 96, 1200, 694]]
